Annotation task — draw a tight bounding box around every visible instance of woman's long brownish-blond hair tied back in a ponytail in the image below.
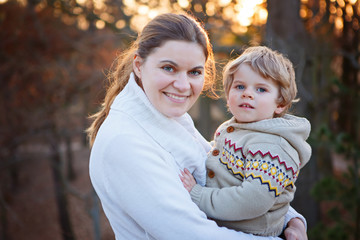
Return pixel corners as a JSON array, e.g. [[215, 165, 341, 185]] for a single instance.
[[86, 13, 216, 146]]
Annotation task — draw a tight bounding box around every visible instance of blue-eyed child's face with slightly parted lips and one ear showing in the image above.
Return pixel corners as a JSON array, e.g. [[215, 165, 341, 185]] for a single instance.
[[227, 63, 285, 123]]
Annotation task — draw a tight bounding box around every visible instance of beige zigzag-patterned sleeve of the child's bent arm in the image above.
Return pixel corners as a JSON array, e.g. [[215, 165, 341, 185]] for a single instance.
[[190, 142, 295, 221]]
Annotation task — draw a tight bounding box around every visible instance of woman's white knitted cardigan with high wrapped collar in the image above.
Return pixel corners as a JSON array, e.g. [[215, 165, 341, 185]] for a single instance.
[[90, 75, 305, 240]]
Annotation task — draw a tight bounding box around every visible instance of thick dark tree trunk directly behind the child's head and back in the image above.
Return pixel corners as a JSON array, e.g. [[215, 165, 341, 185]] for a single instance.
[[265, 0, 319, 227]]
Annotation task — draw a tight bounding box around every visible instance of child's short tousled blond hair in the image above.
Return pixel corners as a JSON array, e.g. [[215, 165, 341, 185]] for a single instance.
[[223, 46, 298, 117]]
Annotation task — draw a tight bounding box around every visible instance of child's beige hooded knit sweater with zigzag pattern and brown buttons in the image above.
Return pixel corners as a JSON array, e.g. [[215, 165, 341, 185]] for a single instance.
[[190, 115, 311, 236]]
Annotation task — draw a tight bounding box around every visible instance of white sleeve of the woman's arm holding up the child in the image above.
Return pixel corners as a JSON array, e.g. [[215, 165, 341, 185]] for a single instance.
[[92, 135, 279, 240]]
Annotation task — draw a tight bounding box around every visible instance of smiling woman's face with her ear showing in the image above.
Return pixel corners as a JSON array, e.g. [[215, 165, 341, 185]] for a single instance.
[[133, 40, 206, 117]]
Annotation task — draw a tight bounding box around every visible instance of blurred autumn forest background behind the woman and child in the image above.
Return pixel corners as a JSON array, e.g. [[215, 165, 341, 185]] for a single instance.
[[0, 0, 360, 240]]
